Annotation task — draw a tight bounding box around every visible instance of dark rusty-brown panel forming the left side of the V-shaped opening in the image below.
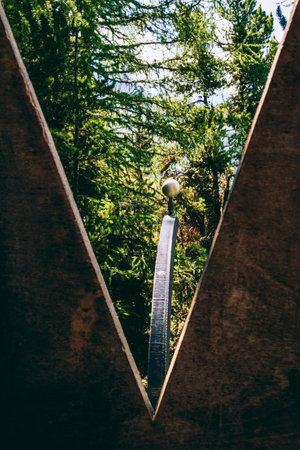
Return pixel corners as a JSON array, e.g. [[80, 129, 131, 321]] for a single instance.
[[0, 5, 151, 449]]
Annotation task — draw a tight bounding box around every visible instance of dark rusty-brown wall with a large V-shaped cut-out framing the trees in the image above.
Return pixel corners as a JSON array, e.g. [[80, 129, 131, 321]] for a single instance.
[[0, 1, 300, 450]]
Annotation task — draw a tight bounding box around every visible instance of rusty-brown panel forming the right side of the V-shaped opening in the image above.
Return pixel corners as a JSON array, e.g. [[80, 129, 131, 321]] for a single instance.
[[156, 2, 300, 449]]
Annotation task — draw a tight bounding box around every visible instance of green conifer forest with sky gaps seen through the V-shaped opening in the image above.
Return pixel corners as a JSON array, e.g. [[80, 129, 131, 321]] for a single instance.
[[2, 0, 286, 377]]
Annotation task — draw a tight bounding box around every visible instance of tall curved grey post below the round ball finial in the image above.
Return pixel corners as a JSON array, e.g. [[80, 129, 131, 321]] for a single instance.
[[147, 215, 178, 407]]
